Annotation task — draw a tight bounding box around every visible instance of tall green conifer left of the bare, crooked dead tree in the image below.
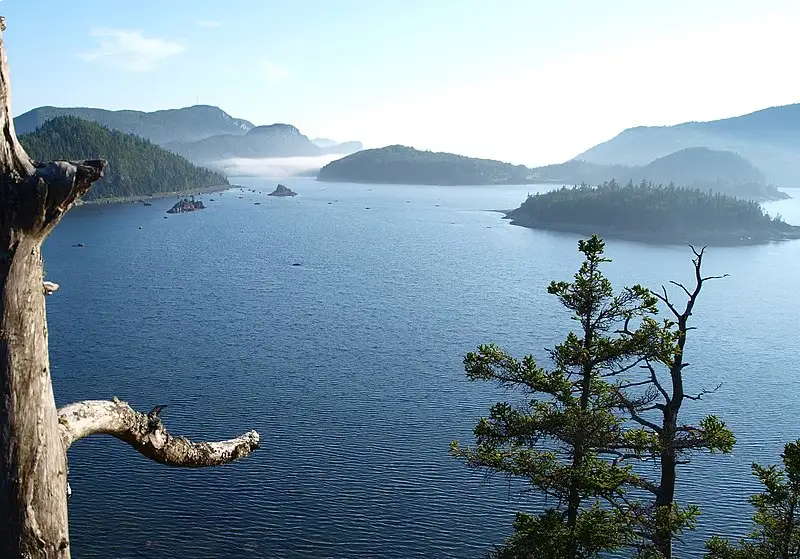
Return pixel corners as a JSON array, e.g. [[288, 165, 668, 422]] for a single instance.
[[451, 236, 664, 558]]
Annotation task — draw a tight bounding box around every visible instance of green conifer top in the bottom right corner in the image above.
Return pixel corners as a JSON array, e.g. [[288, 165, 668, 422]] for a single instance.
[[706, 440, 800, 559]]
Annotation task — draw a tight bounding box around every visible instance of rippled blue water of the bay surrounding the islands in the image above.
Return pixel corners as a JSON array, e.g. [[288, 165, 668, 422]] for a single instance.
[[44, 179, 800, 559]]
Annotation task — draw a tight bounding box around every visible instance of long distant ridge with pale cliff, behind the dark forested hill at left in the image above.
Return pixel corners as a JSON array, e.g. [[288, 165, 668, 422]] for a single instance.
[[14, 105, 253, 145]]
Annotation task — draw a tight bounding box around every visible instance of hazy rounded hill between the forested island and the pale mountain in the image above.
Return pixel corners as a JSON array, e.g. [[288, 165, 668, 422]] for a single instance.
[[533, 148, 789, 202]]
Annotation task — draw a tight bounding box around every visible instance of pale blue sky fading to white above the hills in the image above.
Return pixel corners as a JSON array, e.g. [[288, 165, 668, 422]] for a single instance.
[[0, 0, 800, 165]]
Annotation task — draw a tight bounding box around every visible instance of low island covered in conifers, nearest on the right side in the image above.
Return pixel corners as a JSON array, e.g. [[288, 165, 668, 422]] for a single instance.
[[506, 181, 800, 246]]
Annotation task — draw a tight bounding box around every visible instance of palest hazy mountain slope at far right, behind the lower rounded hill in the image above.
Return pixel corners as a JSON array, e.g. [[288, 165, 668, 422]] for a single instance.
[[575, 104, 800, 186]]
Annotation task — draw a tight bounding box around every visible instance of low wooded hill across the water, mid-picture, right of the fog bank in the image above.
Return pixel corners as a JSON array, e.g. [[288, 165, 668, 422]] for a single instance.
[[317, 145, 531, 185]]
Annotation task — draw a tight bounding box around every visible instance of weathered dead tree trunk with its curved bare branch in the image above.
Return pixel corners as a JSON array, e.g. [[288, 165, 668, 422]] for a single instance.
[[0, 18, 258, 559]]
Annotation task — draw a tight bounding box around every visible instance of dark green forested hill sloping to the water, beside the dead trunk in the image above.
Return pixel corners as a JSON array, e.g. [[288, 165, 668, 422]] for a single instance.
[[19, 116, 228, 200]]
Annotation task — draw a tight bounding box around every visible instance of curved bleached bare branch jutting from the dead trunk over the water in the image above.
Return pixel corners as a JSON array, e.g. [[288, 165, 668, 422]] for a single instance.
[[58, 398, 259, 468]]
